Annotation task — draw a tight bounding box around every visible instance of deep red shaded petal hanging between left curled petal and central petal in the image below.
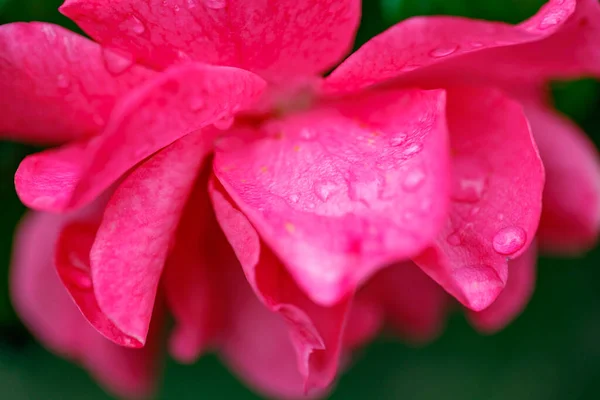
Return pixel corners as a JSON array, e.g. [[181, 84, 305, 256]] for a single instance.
[[163, 164, 232, 363]]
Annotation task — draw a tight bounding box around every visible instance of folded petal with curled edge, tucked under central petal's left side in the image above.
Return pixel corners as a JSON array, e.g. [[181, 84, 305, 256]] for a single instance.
[[209, 179, 350, 397]]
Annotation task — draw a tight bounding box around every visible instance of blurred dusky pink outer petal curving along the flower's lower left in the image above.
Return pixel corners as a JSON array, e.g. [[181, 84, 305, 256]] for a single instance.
[[11, 213, 162, 397]]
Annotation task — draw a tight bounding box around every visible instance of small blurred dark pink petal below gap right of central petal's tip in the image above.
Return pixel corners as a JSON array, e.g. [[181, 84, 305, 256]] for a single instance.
[[358, 262, 450, 343]]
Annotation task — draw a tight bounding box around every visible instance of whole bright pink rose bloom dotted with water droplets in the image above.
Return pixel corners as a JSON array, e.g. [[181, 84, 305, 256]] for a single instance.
[[0, 0, 600, 398]]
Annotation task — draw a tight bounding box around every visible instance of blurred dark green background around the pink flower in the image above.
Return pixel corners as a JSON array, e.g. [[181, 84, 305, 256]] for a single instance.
[[0, 0, 600, 400]]
